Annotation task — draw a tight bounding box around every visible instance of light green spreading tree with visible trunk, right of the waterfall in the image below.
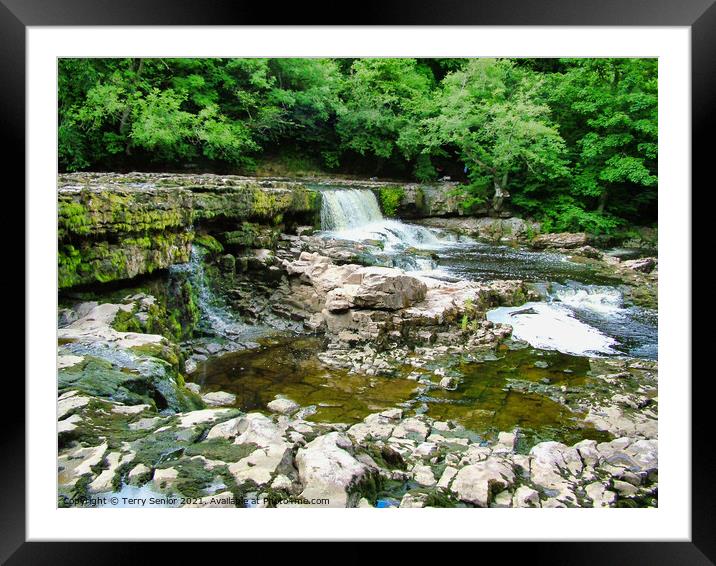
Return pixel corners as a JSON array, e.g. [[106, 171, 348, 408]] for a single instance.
[[422, 59, 567, 210]]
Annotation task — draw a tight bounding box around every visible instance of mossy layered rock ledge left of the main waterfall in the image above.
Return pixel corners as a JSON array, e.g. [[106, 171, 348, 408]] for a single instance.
[[58, 173, 320, 288]]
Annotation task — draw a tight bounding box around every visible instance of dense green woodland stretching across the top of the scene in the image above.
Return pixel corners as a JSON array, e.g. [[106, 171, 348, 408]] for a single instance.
[[58, 59, 658, 233]]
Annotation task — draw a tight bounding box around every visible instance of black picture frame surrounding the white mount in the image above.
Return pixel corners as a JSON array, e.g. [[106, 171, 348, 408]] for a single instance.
[[0, 0, 716, 564]]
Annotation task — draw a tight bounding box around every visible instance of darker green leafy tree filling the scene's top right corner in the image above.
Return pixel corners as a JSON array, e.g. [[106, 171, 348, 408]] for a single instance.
[[549, 59, 658, 222]]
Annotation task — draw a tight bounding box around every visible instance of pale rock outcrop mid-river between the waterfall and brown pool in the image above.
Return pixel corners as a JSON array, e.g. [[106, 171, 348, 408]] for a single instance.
[[271, 252, 530, 348]]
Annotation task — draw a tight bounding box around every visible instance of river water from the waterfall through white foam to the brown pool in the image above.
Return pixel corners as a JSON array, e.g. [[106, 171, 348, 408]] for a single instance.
[[192, 189, 657, 448]]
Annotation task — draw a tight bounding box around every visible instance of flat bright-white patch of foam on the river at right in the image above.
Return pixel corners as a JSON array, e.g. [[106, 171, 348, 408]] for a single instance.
[[487, 303, 617, 356]]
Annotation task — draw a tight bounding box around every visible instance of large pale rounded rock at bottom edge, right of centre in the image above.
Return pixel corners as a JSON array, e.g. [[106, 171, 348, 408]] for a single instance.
[[450, 457, 515, 507]]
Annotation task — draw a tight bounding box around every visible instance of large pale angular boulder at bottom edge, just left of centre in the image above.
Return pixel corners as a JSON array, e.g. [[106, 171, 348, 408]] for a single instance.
[[296, 432, 371, 507]]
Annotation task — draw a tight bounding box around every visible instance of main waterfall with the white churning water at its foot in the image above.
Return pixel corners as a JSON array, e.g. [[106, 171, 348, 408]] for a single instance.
[[321, 189, 455, 251]]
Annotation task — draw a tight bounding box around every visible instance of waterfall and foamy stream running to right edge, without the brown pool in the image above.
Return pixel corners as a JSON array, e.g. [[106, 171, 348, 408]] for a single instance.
[[314, 188, 658, 359]]
